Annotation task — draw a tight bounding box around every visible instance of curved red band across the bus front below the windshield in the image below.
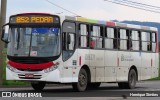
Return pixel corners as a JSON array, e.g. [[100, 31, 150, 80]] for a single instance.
[[8, 61, 54, 70]]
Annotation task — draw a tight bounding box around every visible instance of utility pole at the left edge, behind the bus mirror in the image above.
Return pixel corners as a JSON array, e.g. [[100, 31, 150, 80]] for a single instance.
[[0, 0, 7, 85]]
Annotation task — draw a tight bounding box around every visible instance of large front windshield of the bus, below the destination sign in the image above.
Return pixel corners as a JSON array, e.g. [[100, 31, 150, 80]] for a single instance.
[[7, 27, 60, 57]]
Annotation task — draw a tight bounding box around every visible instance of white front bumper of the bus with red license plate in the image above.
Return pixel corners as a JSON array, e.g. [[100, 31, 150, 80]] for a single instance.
[[6, 67, 60, 82]]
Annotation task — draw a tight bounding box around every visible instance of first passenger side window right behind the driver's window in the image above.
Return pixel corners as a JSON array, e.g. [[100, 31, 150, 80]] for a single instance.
[[79, 24, 89, 47]]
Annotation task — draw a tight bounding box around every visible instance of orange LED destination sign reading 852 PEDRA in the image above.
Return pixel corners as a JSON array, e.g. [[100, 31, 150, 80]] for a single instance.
[[10, 15, 59, 23]]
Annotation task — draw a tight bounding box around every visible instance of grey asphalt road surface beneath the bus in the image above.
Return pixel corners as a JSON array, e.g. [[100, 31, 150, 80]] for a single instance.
[[0, 81, 160, 100]]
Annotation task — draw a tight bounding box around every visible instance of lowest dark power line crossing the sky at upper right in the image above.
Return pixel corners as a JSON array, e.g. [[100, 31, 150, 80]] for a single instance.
[[104, 0, 160, 13]]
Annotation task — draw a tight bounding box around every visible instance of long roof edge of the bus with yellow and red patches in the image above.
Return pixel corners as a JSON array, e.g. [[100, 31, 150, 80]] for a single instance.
[[65, 16, 158, 31]]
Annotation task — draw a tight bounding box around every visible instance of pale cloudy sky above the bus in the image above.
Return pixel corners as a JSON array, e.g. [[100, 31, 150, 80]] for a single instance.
[[6, 0, 160, 23]]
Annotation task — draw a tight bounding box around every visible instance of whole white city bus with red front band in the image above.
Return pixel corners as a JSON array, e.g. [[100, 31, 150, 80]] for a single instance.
[[2, 13, 159, 91]]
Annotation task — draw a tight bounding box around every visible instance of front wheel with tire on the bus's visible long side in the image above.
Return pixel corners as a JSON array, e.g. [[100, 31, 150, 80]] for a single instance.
[[72, 68, 88, 92]]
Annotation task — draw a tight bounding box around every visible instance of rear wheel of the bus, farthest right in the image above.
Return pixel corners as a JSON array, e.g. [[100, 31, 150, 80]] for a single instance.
[[126, 69, 137, 89]]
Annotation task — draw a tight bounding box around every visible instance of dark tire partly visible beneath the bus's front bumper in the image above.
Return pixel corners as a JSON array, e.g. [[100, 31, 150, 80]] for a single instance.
[[31, 82, 46, 91]]
